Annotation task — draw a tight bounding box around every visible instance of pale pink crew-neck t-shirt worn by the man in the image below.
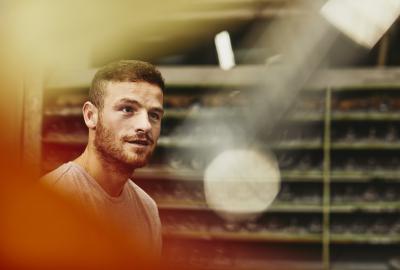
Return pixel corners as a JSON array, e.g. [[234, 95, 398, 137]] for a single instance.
[[41, 161, 161, 257]]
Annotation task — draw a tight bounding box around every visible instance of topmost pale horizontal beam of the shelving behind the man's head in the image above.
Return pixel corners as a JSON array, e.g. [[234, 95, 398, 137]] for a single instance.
[[45, 65, 400, 91]]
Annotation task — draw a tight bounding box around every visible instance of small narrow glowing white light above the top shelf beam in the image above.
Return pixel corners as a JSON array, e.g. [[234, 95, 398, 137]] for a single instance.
[[214, 31, 235, 70]]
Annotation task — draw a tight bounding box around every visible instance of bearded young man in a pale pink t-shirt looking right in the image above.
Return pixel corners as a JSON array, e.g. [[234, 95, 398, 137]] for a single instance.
[[43, 61, 164, 256]]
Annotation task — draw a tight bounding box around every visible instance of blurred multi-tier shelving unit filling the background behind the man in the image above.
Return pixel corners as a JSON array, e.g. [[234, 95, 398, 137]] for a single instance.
[[27, 67, 400, 269]]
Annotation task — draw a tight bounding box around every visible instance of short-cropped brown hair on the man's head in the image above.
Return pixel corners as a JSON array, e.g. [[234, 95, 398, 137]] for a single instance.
[[89, 60, 165, 109]]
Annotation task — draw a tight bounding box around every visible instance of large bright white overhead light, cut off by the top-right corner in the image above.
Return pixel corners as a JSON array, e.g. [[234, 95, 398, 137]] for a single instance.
[[320, 0, 400, 48]]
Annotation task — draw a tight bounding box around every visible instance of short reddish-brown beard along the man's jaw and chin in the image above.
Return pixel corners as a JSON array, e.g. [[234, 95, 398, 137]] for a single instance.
[[94, 118, 151, 170]]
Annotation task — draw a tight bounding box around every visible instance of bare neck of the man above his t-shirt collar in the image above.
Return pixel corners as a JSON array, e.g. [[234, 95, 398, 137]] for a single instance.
[[74, 146, 133, 197]]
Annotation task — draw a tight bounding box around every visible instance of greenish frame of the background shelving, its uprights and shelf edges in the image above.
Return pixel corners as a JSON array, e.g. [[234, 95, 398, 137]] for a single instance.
[[26, 66, 400, 269]]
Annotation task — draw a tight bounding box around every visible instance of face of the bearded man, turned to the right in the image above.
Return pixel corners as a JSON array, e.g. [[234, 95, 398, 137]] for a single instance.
[[94, 81, 163, 168]]
